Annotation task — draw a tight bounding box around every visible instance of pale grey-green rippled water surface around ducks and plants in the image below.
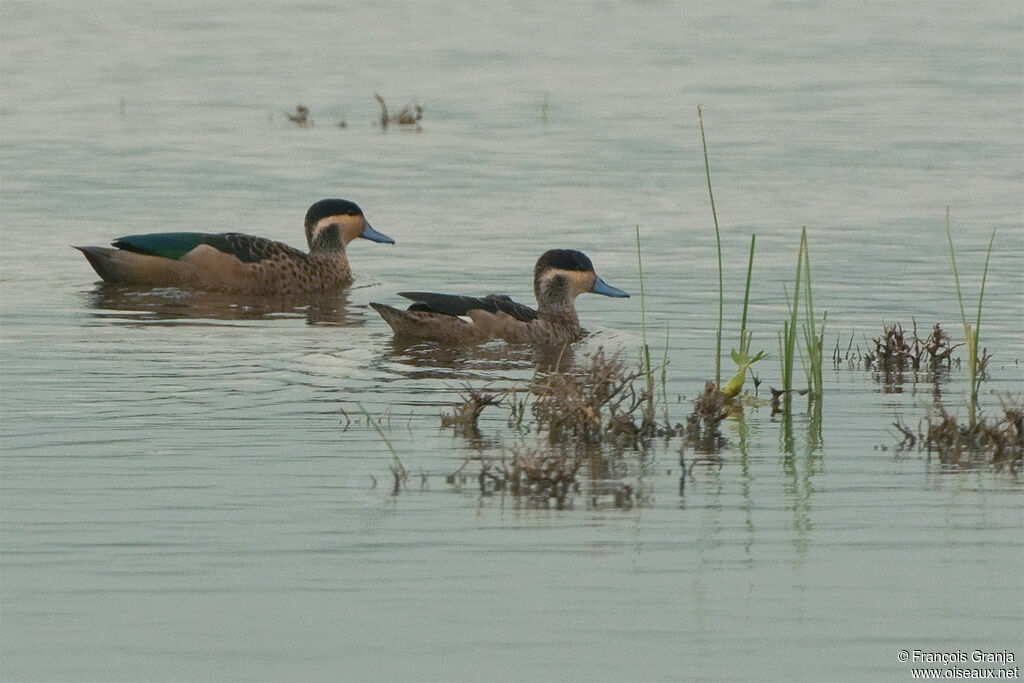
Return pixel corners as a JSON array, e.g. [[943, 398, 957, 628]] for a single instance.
[[0, 0, 1024, 681]]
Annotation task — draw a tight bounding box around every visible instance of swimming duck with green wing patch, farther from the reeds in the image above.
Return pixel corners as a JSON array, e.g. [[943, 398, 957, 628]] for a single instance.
[[75, 199, 394, 294]]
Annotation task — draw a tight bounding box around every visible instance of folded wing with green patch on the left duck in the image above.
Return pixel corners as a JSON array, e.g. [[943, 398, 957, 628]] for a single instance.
[[113, 232, 305, 263]]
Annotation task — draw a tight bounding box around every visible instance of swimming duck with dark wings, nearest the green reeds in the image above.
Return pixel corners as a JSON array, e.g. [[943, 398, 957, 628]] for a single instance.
[[370, 249, 629, 345]]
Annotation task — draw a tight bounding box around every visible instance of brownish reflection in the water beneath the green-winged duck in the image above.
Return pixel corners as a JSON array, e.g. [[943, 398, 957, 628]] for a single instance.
[[81, 283, 362, 326]]
